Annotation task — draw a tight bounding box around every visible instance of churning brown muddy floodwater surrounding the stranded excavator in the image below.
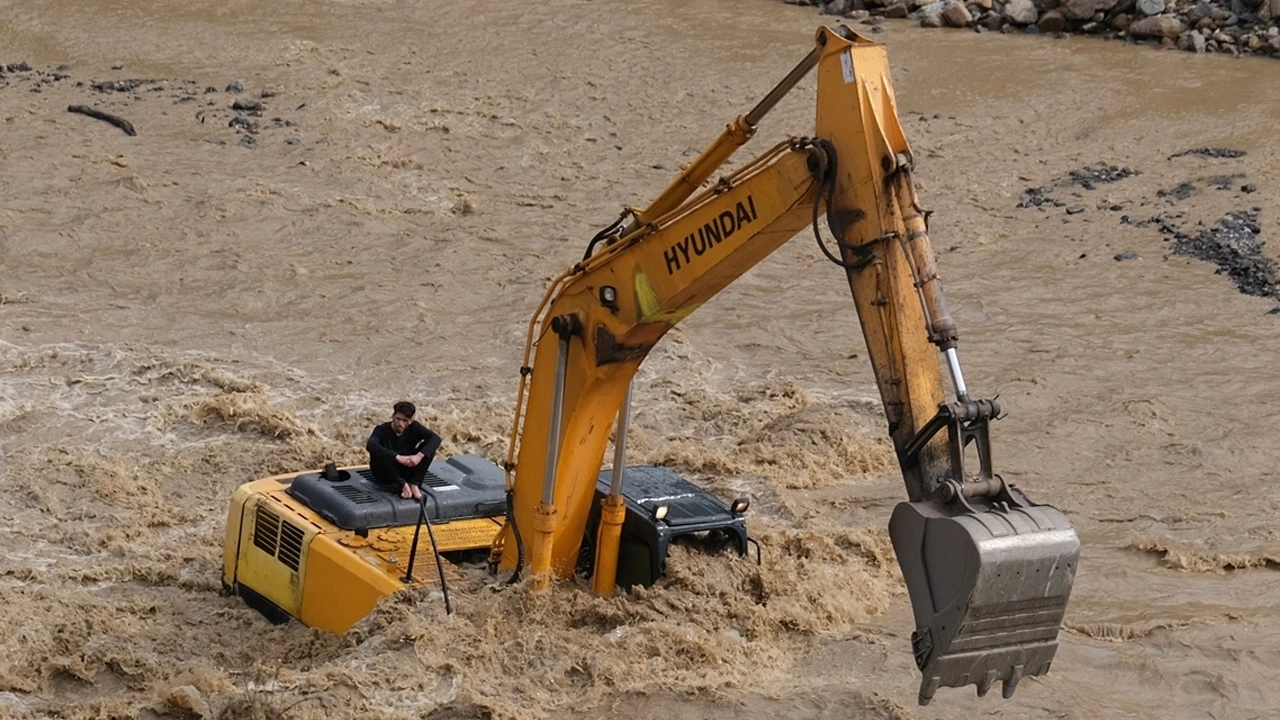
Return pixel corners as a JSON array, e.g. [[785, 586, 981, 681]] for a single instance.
[[0, 0, 1280, 719]]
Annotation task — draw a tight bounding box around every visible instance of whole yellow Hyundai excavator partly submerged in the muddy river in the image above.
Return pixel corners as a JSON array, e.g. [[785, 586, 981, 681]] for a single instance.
[[223, 26, 1080, 705]]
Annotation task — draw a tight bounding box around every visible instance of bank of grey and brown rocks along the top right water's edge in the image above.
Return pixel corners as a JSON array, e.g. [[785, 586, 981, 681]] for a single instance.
[[785, 0, 1280, 58]]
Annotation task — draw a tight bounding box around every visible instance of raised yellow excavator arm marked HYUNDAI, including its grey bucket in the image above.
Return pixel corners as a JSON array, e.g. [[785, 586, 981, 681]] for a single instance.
[[494, 27, 1079, 705]]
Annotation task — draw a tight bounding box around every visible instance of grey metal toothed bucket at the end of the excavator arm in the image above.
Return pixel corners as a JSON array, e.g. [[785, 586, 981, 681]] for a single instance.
[[888, 491, 1080, 705]]
